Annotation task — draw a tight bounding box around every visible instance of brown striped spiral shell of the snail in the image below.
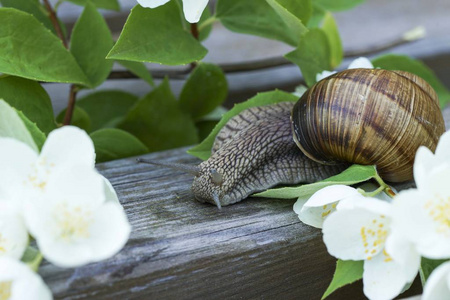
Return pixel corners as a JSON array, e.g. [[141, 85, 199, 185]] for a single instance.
[[291, 69, 445, 182]]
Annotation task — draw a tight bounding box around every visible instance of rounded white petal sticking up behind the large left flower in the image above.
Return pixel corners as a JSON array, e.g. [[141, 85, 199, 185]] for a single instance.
[[39, 126, 95, 168]]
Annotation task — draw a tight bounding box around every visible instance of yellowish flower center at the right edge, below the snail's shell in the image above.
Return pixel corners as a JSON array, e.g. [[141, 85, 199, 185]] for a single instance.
[[425, 194, 450, 237]]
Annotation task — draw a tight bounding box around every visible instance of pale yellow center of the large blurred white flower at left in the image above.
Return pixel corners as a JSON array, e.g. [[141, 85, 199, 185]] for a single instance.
[[53, 202, 92, 242]]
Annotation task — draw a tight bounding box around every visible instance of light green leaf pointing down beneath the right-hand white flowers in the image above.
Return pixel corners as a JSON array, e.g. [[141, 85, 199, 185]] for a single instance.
[[322, 259, 364, 300]]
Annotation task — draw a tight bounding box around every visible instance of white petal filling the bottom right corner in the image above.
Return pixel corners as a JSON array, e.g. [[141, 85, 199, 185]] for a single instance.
[[422, 261, 450, 300]]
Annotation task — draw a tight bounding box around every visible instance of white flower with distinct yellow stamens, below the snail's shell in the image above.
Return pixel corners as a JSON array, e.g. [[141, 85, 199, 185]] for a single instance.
[[323, 197, 420, 299]]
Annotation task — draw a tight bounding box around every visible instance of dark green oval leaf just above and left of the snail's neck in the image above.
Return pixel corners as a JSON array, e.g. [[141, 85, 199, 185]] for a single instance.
[[180, 63, 228, 120]]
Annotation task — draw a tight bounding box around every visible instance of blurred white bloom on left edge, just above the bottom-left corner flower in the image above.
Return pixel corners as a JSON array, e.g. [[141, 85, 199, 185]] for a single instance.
[[0, 201, 28, 260]]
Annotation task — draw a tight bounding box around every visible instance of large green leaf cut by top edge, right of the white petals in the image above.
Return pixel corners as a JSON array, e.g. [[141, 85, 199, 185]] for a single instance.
[[216, 0, 310, 46]]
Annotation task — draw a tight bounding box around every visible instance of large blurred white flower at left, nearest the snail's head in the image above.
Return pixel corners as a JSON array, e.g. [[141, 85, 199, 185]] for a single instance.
[[25, 166, 130, 267]]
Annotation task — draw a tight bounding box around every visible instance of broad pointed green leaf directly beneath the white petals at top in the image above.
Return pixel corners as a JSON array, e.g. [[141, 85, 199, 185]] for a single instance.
[[108, 1, 207, 65]]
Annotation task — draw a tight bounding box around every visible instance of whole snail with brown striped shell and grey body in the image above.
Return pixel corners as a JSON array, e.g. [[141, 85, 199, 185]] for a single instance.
[[139, 69, 445, 208]]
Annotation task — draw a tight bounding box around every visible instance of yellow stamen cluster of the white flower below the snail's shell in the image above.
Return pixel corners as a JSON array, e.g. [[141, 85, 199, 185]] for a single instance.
[[360, 215, 388, 260]]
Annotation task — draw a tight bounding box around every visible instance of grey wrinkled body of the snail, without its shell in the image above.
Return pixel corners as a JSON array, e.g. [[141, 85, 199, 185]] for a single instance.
[[192, 102, 347, 206]]
